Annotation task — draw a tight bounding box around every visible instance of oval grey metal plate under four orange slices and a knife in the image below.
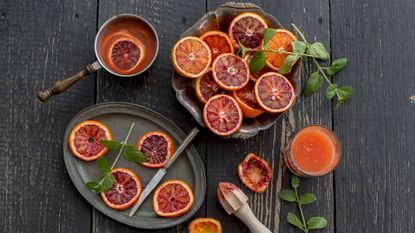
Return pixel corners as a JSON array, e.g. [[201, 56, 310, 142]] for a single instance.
[[63, 103, 206, 229]]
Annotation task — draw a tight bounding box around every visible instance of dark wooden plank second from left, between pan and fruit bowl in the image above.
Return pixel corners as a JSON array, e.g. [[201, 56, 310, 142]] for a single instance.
[[93, 0, 206, 232]]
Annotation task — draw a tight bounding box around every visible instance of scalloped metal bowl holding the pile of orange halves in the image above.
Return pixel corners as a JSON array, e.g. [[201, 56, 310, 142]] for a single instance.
[[172, 2, 302, 138]]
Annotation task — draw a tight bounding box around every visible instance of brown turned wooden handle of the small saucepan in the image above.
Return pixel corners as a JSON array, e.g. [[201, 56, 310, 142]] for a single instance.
[[38, 64, 99, 102]]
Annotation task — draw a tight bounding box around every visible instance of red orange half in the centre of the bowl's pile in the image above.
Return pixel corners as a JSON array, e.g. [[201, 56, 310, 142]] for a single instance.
[[212, 53, 249, 91]]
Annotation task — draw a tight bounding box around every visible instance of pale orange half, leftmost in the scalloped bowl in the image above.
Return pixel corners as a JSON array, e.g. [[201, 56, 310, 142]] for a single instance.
[[171, 36, 212, 78]]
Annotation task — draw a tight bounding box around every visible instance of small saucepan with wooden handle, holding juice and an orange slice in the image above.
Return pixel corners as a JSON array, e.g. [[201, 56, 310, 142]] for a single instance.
[[38, 14, 159, 101]]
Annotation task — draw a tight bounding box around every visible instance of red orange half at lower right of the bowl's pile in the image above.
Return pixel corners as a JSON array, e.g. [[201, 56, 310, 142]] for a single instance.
[[254, 72, 295, 113]]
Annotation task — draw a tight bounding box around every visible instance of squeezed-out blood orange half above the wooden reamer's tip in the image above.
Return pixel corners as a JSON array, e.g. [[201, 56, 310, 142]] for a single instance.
[[238, 153, 272, 193]]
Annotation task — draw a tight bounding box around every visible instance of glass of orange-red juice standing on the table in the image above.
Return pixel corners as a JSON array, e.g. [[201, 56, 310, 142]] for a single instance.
[[284, 125, 341, 177]]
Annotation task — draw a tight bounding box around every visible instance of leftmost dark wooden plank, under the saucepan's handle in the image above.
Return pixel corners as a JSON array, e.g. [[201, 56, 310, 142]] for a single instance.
[[0, 0, 96, 233]]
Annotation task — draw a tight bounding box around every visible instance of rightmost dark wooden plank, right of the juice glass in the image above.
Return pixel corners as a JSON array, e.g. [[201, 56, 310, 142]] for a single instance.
[[331, 0, 415, 233]]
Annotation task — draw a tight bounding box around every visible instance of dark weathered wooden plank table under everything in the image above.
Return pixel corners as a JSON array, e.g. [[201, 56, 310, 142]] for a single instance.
[[0, 0, 415, 233]]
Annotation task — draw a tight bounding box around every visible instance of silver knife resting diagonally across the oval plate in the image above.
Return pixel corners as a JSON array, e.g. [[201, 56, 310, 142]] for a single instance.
[[128, 128, 199, 217]]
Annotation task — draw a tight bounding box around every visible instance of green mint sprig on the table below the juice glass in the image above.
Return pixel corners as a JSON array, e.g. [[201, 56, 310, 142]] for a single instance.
[[278, 176, 327, 233]]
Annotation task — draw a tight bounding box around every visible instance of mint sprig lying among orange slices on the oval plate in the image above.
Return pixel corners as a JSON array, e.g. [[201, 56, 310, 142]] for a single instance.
[[86, 123, 146, 194]]
